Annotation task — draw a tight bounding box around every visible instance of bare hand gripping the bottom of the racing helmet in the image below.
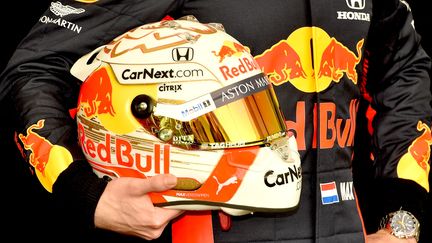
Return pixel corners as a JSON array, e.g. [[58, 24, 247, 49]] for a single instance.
[[94, 174, 182, 240]]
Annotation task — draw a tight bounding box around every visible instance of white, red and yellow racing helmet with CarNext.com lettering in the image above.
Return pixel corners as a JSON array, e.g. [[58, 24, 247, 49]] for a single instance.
[[71, 16, 302, 215]]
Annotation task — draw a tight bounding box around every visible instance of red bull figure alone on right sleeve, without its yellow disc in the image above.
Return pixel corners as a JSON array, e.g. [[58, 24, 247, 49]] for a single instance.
[[408, 121, 432, 170]]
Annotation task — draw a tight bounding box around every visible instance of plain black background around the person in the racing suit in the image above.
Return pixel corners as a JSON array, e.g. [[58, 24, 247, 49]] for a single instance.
[[0, 0, 432, 243]]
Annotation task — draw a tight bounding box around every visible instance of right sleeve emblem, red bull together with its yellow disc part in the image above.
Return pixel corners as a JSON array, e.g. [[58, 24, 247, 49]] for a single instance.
[[397, 121, 432, 191]]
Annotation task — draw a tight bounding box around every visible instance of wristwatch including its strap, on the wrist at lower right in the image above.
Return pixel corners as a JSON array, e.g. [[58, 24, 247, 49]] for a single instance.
[[381, 209, 420, 242]]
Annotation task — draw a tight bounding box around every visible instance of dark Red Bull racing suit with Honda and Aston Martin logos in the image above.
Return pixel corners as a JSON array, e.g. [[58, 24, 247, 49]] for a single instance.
[[0, 0, 432, 243]]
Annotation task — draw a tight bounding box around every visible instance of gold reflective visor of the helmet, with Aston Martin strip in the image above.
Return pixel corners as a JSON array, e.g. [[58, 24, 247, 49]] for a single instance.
[[142, 74, 286, 149]]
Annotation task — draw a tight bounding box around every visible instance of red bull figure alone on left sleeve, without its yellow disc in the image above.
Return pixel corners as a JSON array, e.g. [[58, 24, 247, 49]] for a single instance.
[[19, 120, 53, 174]]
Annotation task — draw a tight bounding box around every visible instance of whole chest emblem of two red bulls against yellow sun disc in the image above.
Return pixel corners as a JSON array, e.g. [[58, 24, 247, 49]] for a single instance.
[[255, 27, 364, 93]]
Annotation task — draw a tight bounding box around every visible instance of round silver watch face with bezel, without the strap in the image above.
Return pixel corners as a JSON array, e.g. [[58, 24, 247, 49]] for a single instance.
[[390, 211, 418, 238]]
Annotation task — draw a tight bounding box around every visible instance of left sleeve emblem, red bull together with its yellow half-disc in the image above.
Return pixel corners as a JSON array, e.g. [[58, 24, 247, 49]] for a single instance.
[[18, 120, 73, 192]]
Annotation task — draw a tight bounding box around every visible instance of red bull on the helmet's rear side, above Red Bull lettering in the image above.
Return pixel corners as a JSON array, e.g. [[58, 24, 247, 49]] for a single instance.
[[78, 68, 115, 117]]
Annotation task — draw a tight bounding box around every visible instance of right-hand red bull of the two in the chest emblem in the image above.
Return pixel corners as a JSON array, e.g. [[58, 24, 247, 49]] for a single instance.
[[318, 38, 364, 84]]
